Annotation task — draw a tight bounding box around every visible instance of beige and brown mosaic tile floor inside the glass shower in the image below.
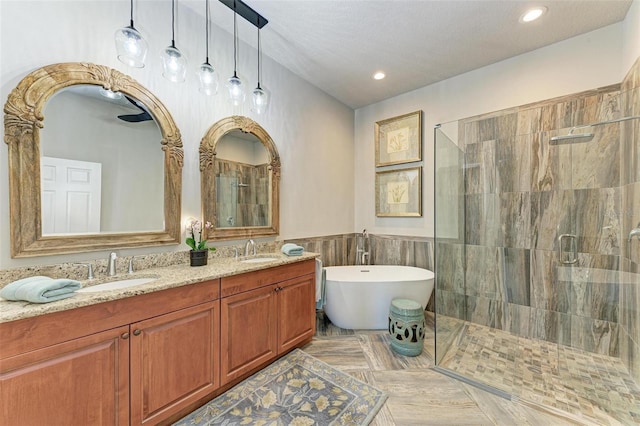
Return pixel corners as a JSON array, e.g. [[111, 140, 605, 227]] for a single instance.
[[437, 319, 640, 425]]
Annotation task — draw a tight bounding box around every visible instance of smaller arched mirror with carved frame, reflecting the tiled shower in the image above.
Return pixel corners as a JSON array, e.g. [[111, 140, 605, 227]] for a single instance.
[[200, 116, 280, 240]]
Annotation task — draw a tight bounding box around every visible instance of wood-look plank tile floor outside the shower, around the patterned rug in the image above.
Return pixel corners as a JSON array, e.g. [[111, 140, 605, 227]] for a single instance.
[[312, 313, 622, 426]]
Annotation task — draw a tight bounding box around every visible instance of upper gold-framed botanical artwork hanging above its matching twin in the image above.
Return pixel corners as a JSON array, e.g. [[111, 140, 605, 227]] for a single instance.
[[375, 111, 422, 167]]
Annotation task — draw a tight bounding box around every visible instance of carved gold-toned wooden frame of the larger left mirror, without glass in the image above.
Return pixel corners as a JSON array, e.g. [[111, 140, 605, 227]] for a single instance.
[[4, 62, 184, 258]]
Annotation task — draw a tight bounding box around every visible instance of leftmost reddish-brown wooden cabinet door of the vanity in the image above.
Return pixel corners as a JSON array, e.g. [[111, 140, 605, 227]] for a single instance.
[[0, 327, 129, 425]]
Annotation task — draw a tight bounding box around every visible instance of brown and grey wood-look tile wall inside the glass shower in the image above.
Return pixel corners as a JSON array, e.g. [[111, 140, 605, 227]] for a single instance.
[[436, 73, 640, 362]]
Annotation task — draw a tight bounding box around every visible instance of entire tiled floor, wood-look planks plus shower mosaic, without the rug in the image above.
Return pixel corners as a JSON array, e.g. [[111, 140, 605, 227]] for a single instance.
[[312, 313, 640, 426]]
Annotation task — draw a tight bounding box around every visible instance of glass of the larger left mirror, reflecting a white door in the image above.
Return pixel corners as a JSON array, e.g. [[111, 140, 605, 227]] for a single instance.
[[40, 85, 164, 236]]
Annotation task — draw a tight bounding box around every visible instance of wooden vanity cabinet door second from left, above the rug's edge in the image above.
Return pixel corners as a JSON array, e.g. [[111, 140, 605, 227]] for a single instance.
[[131, 301, 220, 425]]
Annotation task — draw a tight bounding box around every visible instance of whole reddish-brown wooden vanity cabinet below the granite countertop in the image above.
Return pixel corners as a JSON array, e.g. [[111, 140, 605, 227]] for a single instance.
[[0, 259, 315, 425]]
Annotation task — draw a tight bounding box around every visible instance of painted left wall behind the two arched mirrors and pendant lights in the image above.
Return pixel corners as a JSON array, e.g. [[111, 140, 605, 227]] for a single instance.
[[0, 0, 354, 268]]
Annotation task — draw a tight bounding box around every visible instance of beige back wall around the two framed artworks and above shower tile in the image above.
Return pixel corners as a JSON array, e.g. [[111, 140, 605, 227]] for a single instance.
[[354, 23, 638, 237]]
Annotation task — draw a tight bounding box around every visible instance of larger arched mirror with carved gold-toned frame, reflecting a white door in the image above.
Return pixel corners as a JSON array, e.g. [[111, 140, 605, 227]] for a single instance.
[[4, 62, 183, 258]]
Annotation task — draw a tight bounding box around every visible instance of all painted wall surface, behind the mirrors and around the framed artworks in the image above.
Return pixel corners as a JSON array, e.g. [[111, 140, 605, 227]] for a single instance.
[[0, 0, 640, 268]]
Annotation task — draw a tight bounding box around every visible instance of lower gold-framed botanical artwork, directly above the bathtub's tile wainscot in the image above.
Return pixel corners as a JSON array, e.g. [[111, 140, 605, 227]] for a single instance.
[[376, 167, 422, 217]]
